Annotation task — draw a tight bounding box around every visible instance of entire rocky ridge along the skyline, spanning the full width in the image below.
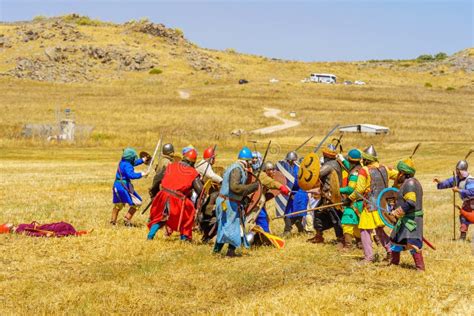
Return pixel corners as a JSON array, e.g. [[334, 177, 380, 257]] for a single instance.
[[0, 14, 474, 82]]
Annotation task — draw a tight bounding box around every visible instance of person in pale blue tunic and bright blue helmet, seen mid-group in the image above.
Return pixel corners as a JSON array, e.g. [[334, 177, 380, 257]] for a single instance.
[[214, 147, 258, 257]]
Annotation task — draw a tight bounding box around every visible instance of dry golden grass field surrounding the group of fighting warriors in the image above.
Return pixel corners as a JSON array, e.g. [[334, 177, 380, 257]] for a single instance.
[[0, 17, 474, 315]]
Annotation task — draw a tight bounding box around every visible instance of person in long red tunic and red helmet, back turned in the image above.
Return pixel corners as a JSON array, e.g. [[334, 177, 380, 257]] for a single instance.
[[148, 149, 202, 241]]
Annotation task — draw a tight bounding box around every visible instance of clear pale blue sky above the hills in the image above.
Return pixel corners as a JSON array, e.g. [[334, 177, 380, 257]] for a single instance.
[[0, 0, 474, 61]]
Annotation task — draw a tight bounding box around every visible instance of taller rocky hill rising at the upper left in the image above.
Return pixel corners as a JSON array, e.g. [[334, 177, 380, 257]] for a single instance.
[[0, 14, 230, 82]]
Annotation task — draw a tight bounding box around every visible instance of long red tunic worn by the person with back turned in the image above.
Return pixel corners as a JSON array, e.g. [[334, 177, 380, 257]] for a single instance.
[[148, 162, 199, 238]]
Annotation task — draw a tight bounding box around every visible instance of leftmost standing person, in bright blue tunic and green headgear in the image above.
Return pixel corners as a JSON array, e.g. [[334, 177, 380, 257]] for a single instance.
[[110, 148, 148, 226]]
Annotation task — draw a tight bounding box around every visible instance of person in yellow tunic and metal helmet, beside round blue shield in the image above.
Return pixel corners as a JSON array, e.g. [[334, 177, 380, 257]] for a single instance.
[[345, 145, 398, 262]]
